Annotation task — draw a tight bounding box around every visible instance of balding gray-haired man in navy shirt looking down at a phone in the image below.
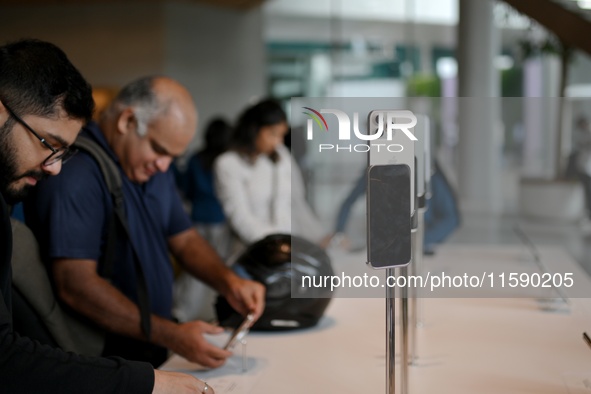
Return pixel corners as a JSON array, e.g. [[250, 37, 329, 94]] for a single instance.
[[25, 77, 264, 367]]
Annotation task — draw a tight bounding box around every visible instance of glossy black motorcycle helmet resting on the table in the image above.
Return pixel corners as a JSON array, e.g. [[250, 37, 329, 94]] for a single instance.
[[216, 234, 333, 331]]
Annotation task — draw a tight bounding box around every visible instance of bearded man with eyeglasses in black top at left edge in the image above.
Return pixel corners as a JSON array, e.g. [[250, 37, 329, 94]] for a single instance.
[[0, 40, 213, 394]]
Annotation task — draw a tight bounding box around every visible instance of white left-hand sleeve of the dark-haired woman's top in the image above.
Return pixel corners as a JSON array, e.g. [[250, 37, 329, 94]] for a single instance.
[[214, 152, 277, 244]]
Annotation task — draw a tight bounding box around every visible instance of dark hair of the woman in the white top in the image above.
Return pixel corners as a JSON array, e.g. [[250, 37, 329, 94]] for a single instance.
[[232, 99, 287, 161]]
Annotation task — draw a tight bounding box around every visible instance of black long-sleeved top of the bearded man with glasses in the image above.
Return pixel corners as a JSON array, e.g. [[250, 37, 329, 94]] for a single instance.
[[0, 195, 154, 394]]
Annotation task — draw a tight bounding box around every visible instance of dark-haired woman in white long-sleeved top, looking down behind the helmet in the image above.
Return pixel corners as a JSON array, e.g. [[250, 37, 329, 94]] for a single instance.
[[214, 100, 326, 249]]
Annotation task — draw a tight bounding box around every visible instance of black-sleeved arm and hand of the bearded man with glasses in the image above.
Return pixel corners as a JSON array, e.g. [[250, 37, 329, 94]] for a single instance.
[[0, 327, 214, 394]]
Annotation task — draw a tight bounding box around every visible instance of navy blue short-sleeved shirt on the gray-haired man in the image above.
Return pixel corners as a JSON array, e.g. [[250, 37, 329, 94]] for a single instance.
[[25, 123, 191, 318]]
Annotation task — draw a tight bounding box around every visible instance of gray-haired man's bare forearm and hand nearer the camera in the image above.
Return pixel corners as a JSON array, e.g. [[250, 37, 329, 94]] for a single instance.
[[53, 259, 232, 368]]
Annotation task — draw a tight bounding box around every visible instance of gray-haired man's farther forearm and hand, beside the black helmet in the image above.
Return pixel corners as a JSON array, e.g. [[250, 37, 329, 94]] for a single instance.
[[168, 228, 265, 319]]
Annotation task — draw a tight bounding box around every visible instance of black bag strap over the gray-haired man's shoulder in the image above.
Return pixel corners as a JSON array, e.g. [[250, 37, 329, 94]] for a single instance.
[[74, 136, 151, 340]]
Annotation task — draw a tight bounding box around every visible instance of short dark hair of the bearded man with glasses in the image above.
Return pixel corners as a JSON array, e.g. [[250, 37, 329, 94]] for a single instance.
[[0, 39, 94, 122]]
